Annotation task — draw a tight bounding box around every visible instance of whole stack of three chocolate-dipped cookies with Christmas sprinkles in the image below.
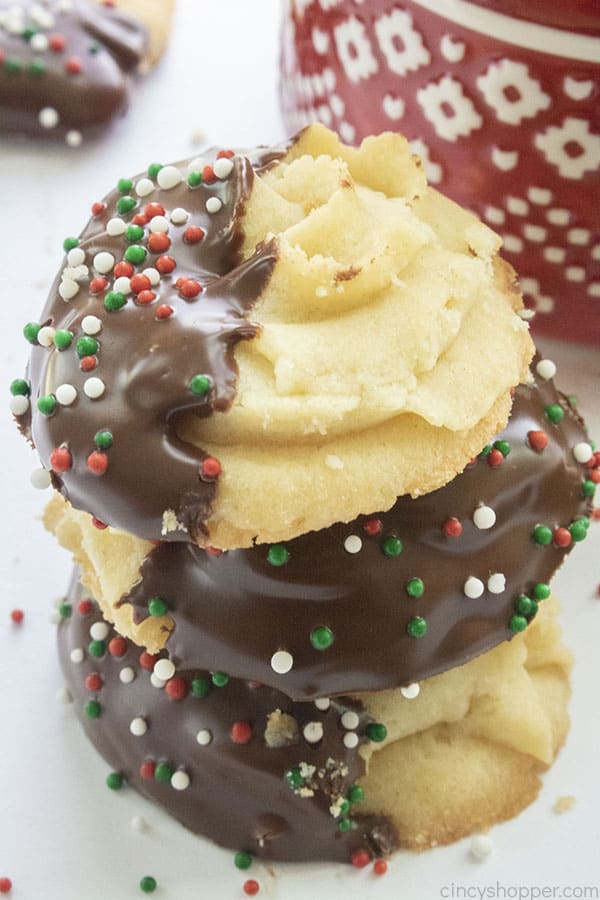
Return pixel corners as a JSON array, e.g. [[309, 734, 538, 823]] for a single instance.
[[14, 126, 600, 862]]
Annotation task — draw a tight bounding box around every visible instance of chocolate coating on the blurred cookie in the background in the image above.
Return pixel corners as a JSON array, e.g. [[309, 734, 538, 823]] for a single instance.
[[0, 0, 147, 137]]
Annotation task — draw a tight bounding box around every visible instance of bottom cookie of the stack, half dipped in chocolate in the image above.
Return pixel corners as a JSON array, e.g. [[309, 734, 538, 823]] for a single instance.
[[59, 580, 571, 861]]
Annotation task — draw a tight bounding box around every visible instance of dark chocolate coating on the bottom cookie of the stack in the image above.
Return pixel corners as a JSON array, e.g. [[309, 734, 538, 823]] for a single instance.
[[58, 581, 397, 861]]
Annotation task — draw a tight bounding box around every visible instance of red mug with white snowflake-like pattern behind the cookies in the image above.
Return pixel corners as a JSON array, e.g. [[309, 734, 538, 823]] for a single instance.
[[281, 0, 600, 343]]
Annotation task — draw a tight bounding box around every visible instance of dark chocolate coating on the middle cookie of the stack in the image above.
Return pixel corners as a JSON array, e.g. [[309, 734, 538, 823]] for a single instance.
[[122, 370, 597, 700]]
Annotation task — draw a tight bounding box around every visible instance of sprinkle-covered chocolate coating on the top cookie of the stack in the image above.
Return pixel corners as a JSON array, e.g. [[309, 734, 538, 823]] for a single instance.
[[21, 150, 283, 540]]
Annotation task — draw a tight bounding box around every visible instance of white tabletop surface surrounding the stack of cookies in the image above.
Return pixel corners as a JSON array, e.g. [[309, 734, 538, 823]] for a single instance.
[[0, 0, 600, 900]]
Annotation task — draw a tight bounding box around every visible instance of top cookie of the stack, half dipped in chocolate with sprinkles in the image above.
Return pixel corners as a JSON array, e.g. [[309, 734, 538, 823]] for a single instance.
[[21, 126, 533, 548]]
